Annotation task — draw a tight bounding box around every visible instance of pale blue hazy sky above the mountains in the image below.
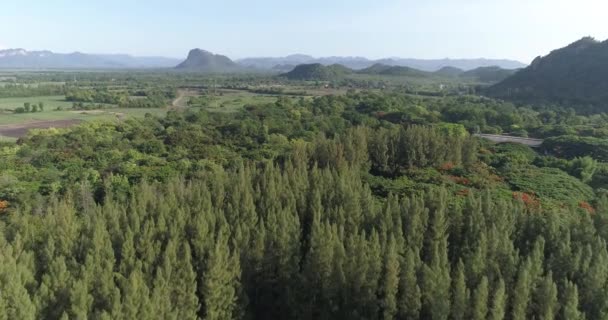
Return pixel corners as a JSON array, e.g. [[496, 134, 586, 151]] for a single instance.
[[0, 0, 608, 62]]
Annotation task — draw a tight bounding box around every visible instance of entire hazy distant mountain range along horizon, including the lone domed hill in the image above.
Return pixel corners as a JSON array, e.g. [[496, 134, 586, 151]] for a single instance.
[[0, 49, 525, 73]]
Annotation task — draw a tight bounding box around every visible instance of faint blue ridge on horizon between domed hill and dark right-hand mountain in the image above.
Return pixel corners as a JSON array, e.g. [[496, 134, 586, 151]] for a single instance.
[[237, 54, 526, 72]]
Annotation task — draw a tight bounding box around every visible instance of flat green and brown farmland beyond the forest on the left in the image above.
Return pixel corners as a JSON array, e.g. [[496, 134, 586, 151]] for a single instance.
[[0, 72, 346, 141]]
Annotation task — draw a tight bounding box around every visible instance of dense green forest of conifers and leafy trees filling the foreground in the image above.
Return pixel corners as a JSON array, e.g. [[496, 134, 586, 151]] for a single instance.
[[0, 69, 608, 320]]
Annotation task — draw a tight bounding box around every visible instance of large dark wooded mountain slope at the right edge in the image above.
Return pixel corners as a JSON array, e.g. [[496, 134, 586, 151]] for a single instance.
[[485, 37, 608, 111]]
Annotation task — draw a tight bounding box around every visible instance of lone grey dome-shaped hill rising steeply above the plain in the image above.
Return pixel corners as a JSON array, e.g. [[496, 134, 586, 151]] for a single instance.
[[175, 49, 241, 72]]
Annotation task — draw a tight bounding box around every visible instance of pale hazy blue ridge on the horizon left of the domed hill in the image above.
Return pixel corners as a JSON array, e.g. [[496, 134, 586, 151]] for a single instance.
[[0, 49, 177, 69]]
